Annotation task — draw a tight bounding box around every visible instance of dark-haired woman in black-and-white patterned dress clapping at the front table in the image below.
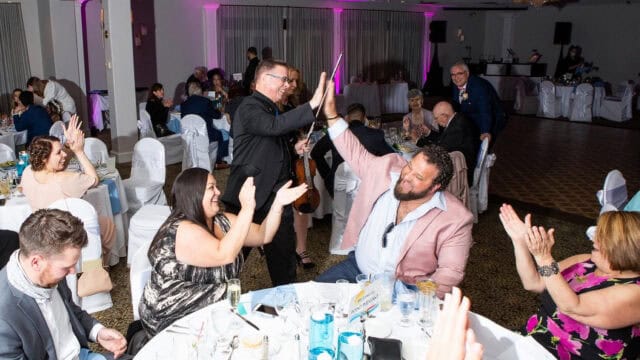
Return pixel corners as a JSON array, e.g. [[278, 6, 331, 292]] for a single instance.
[[139, 168, 306, 337]]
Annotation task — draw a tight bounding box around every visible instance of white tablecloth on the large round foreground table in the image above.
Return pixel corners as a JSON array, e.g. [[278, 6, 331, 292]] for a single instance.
[[135, 282, 554, 360]]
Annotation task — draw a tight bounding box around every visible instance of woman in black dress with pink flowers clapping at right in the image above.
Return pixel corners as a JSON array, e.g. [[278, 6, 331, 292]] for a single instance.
[[500, 204, 640, 359]]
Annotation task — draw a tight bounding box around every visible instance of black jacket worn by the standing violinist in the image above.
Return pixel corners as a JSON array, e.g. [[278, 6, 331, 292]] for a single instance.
[[222, 91, 315, 218]]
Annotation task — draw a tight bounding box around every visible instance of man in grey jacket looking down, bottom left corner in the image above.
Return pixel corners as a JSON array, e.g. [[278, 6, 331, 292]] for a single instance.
[[0, 209, 127, 360]]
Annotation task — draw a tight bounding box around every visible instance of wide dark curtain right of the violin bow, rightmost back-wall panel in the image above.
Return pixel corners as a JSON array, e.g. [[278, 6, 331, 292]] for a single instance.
[[342, 10, 424, 88]]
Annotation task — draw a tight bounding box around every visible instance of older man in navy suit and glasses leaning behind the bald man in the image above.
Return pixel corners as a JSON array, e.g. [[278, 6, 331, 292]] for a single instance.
[[451, 61, 506, 144]]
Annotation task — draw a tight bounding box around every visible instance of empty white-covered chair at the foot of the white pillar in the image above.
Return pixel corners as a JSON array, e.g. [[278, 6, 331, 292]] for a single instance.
[[123, 138, 167, 213]]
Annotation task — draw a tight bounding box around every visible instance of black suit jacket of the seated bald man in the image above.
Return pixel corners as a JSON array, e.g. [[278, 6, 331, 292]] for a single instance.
[[417, 113, 480, 184]]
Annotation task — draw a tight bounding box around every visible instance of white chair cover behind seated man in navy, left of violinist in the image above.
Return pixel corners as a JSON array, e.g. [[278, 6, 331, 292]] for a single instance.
[[180, 114, 212, 171]]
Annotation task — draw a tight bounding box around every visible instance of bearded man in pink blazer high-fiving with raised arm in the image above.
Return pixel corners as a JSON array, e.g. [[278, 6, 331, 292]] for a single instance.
[[316, 84, 473, 297]]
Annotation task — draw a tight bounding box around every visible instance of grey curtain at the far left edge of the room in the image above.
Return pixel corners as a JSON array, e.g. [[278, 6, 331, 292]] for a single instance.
[[0, 3, 31, 113]]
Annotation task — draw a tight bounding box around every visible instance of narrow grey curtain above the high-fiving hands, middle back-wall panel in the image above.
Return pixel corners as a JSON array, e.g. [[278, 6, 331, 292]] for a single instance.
[[286, 8, 335, 91]]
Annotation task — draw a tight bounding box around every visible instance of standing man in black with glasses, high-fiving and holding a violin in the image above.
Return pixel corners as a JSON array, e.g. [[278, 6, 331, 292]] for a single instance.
[[222, 60, 326, 286]]
